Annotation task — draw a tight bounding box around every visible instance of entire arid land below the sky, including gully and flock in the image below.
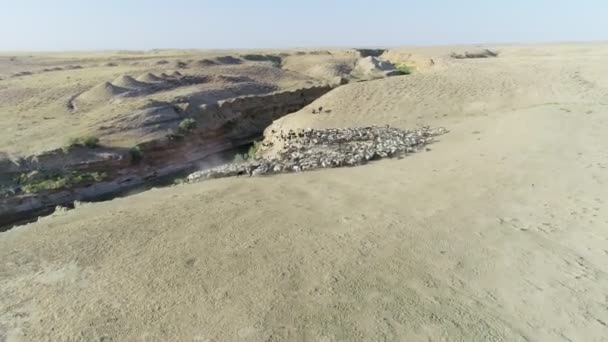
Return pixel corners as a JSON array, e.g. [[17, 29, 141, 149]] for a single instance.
[[0, 42, 608, 342]]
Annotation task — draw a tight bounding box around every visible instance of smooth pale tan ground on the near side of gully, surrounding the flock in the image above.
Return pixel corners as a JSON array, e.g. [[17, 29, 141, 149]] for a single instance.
[[0, 44, 608, 341]]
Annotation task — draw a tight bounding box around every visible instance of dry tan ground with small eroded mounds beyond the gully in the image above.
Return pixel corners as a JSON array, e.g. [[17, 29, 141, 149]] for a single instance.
[[0, 50, 358, 157]]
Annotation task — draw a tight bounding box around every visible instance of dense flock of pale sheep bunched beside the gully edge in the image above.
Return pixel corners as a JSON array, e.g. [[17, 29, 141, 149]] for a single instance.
[[188, 127, 447, 182]]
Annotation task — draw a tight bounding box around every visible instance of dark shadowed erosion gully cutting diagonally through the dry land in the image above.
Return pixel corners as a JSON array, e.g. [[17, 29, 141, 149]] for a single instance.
[[0, 86, 332, 232]]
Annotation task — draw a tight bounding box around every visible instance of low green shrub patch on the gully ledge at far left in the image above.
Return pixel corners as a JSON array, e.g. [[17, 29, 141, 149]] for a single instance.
[[17, 171, 107, 193]]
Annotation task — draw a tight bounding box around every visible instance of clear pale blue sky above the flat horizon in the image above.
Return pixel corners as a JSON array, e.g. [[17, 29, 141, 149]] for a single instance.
[[0, 0, 608, 51]]
